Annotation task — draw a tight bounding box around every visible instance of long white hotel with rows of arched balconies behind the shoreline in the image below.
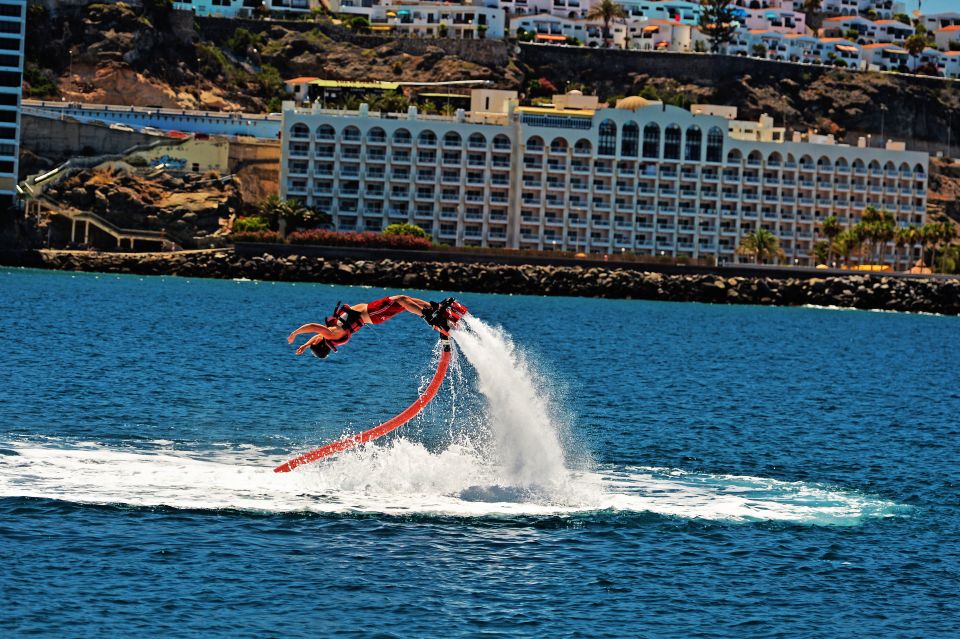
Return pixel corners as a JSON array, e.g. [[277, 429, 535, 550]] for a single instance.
[[281, 90, 928, 264]]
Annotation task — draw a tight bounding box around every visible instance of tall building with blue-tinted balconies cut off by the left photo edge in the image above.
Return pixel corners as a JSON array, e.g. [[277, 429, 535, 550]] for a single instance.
[[0, 0, 27, 205]]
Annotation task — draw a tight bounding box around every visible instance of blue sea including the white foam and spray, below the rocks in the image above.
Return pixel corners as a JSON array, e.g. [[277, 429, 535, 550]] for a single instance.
[[0, 270, 960, 637]]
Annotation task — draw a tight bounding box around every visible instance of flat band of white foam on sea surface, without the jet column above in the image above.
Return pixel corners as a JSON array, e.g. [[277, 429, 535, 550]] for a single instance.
[[0, 439, 903, 525]]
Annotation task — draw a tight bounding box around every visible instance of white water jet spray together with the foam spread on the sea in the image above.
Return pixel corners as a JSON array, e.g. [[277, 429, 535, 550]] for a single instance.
[[0, 318, 903, 525]]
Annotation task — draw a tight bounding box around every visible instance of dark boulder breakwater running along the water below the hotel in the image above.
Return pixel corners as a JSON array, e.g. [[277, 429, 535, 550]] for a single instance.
[[4, 250, 960, 315]]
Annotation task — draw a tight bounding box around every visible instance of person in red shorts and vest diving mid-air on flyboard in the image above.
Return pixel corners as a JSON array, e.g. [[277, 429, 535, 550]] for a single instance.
[[287, 295, 467, 359]]
